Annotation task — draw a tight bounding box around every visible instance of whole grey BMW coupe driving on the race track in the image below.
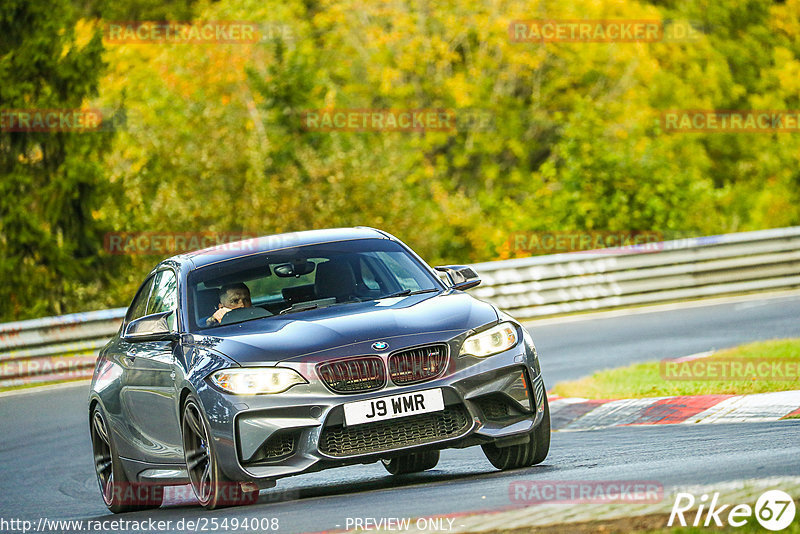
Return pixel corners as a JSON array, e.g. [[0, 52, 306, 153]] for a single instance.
[[88, 227, 550, 512]]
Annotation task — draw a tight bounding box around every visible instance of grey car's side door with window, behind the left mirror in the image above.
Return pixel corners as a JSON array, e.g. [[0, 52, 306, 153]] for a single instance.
[[122, 269, 183, 464]]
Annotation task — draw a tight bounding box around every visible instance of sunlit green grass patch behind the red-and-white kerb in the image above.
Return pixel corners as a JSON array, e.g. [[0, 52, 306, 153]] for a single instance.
[[553, 339, 800, 399]]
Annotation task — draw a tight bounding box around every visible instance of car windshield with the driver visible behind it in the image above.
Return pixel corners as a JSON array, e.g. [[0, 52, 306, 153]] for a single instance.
[[189, 239, 442, 330]]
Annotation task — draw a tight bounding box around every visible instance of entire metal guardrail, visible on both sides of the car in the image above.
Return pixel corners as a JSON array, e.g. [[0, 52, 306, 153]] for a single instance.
[[0, 227, 800, 387]]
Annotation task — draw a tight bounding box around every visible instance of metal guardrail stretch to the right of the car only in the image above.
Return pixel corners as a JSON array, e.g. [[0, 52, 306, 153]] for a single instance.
[[472, 227, 800, 319]]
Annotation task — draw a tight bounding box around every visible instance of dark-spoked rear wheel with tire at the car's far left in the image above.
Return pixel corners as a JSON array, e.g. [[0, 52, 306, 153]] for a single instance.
[[89, 406, 164, 514]]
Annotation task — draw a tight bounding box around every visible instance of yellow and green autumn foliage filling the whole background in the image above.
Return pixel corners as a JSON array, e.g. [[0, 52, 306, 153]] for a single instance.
[[0, 0, 800, 320]]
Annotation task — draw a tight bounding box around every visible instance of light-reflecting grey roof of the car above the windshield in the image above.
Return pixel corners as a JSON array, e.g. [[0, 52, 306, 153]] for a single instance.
[[170, 226, 392, 268]]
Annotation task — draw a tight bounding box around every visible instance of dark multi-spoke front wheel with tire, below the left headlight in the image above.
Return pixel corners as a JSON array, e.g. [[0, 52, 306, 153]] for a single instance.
[[181, 395, 258, 510]]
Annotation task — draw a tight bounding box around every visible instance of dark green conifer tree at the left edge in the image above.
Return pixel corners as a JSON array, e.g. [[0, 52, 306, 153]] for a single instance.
[[0, 0, 112, 320]]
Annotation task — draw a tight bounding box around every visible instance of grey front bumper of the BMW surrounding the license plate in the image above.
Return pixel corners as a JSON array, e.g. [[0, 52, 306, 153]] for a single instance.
[[198, 330, 545, 487]]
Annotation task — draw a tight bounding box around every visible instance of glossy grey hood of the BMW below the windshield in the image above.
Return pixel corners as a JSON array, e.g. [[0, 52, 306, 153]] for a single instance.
[[194, 291, 498, 366]]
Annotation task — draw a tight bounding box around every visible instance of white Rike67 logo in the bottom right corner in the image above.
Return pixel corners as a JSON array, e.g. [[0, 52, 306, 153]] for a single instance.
[[667, 490, 795, 531]]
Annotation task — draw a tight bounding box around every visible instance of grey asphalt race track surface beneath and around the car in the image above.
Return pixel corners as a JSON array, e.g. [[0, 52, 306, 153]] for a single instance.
[[0, 296, 800, 532]]
